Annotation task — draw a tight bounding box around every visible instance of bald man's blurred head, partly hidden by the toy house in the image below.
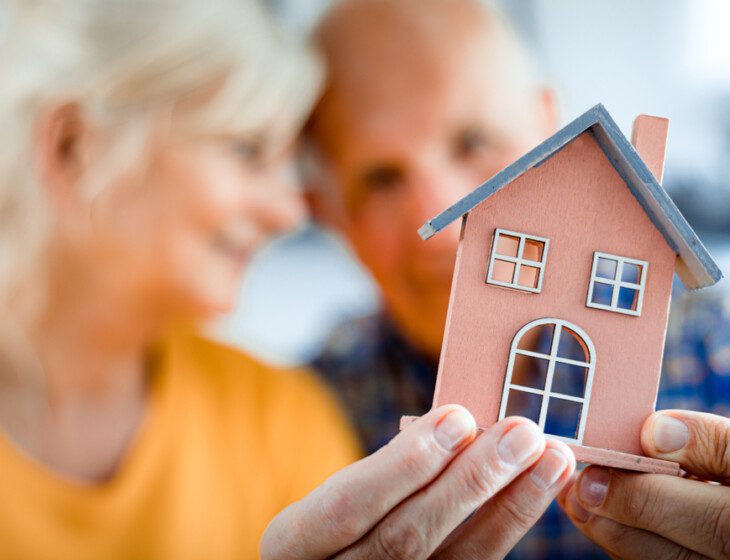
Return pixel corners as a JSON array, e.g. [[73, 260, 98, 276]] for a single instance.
[[309, 0, 555, 356]]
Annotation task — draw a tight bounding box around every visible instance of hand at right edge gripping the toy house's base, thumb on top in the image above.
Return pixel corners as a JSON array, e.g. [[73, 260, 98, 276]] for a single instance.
[[559, 410, 730, 560]]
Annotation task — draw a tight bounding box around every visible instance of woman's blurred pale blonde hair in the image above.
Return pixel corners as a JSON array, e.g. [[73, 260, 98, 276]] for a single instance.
[[0, 0, 322, 320]]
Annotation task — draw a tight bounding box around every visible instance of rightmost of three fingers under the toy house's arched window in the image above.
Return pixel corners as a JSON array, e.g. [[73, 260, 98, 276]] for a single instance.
[[437, 440, 575, 560]]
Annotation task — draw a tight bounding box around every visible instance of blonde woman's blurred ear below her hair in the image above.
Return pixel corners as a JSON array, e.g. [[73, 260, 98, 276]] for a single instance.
[[35, 103, 88, 205]]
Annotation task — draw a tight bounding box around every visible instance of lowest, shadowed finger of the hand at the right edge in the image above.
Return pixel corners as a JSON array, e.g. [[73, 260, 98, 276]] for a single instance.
[[563, 487, 707, 560]]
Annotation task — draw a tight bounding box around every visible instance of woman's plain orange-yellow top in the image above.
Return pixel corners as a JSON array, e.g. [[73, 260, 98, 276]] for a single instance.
[[0, 335, 358, 560]]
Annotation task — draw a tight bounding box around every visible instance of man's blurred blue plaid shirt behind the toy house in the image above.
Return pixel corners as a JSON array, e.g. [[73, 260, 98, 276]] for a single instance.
[[313, 292, 730, 559]]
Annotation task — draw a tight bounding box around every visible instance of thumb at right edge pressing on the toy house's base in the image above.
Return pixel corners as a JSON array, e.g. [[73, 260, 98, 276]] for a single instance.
[[641, 410, 730, 485]]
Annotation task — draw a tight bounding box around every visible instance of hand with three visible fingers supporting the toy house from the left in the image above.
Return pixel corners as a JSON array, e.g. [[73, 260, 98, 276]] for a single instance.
[[261, 405, 575, 560]]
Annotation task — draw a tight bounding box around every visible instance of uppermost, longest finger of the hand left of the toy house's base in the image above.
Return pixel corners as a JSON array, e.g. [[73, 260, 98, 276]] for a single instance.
[[261, 405, 476, 559]]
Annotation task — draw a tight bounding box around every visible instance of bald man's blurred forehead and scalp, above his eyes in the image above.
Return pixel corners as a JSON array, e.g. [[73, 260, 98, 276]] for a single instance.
[[313, 0, 533, 155]]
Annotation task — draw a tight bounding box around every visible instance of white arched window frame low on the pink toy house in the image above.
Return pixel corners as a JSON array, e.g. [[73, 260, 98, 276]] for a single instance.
[[499, 318, 596, 445]]
